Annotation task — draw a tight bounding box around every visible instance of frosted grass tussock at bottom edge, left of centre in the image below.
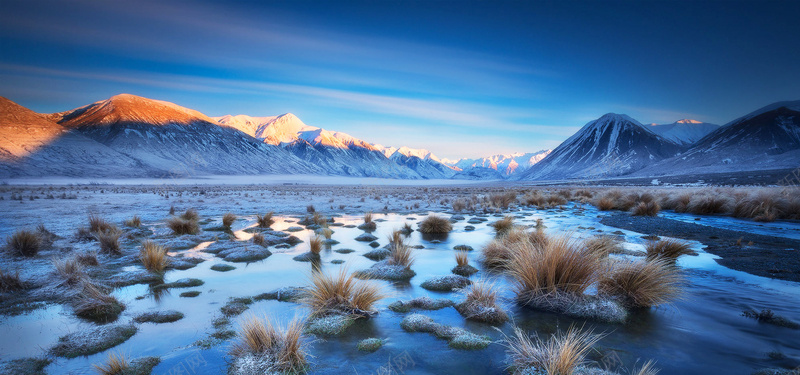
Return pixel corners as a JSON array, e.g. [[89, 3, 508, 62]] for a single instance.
[[231, 317, 308, 374]]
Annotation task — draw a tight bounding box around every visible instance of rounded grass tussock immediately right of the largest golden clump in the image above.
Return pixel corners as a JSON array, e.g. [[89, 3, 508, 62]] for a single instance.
[[597, 258, 683, 308]]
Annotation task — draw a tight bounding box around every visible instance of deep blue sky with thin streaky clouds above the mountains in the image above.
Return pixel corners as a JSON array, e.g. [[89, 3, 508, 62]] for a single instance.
[[0, 0, 800, 159]]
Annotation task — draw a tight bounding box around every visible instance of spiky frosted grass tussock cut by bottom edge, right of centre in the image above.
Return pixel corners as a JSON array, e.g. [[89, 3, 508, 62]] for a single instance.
[[506, 326, 602, 375]]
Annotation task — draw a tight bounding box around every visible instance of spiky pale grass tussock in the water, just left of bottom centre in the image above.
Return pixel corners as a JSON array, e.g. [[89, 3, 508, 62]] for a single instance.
[[304, 268, 386, 316]]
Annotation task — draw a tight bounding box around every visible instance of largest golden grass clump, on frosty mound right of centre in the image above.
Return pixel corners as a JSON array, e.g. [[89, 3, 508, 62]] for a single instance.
[[508, 235, 602, 301]]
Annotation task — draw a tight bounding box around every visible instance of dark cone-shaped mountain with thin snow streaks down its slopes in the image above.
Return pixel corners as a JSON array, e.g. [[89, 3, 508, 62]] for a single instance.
[[517, 113, 681, 180]]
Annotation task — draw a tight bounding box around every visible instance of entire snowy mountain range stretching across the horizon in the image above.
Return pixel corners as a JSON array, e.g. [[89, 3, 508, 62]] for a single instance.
[[0, 94, 800, 180]]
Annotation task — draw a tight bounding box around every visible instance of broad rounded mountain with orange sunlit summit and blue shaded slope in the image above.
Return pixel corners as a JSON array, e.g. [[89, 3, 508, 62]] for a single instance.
[[50, 94, 323, 177]]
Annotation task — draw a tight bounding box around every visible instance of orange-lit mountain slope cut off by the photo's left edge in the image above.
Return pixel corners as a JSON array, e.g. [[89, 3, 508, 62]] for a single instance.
[[0, 97, 154, 177]]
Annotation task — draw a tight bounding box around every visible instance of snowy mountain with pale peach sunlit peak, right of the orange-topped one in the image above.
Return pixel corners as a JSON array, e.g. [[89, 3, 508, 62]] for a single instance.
[[213, 113, 422, 179]]
